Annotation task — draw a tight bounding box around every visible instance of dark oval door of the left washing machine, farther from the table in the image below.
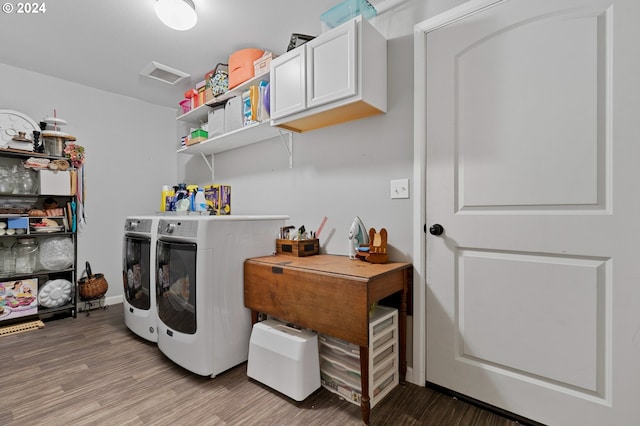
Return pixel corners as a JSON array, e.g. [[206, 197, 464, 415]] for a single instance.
[[122, 235, 152, 311]]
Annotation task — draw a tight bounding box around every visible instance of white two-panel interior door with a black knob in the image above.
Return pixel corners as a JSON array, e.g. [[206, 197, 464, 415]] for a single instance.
[[426, 0, 640, 426]]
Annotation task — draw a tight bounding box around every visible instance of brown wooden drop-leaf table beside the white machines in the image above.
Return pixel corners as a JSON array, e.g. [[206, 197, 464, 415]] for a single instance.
[[244, 254, 412, 424]]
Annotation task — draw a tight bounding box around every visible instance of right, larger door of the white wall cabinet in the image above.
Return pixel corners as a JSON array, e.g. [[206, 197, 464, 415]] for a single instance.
[[305, 20, 358, 108]]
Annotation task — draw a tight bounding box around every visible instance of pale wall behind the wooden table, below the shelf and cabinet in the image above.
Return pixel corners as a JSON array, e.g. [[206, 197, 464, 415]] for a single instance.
[[179, 2, 430, 261]]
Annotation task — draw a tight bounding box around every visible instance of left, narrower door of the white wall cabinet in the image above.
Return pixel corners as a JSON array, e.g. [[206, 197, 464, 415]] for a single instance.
[[270, 46, 306, 119]]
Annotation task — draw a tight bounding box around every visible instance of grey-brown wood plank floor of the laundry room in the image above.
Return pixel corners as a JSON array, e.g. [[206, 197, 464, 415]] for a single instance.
[[0, 305, 517, 426]]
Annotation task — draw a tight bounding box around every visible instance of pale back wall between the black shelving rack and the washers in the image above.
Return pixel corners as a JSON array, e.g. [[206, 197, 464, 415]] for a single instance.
[[0, 64, 177, 297]]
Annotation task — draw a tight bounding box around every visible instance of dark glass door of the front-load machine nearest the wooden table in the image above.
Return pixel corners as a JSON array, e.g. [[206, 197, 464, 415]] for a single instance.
[[156, 240, 197, 334]]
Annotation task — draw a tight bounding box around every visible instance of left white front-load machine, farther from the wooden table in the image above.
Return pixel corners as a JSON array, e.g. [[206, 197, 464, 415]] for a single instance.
[[122, 216, 159, 342]]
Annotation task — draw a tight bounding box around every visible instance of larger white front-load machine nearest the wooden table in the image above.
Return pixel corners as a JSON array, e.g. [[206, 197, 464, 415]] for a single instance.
[[156, 216, 288, 377]]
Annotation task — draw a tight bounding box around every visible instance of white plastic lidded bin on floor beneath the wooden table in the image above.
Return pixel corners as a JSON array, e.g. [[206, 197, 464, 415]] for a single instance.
[[247, 319, 320, 401]]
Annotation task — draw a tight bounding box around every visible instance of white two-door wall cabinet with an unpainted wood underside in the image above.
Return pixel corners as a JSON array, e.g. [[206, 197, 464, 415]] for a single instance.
[[270, 16, 387, 132]]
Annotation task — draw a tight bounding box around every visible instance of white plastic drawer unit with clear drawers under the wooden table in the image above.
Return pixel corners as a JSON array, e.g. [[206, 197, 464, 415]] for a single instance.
[[319, 306, 399, 408]]
